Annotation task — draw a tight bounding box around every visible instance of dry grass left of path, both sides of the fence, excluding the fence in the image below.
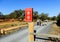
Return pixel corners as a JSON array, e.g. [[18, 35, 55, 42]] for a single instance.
[[0, 21, 27, 35]]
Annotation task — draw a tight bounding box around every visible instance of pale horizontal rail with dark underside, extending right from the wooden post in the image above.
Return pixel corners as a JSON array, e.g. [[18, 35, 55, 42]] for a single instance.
[[30, 30, 60, 42]]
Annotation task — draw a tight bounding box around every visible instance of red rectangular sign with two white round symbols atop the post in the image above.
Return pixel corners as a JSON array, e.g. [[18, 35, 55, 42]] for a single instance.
[[25, 8, 33, 22]]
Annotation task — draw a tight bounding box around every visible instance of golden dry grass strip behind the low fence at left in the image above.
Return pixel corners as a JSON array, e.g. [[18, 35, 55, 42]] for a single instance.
[[0, 21, 27, 28]]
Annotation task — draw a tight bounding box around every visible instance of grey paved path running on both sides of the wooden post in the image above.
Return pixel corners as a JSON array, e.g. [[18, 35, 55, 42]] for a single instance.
[[0, 22, 52, 42]]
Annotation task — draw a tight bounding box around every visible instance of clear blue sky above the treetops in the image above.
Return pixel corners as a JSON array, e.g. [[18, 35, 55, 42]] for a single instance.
[[0, 0, 60, 16]]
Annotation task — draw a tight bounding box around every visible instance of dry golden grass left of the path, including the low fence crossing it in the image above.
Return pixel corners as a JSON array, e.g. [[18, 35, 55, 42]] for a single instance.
[[0, 21, 27, 34]]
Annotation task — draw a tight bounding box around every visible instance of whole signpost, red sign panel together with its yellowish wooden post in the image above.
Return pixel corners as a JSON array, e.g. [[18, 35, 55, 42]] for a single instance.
[[25, 8, 34, 42]]
